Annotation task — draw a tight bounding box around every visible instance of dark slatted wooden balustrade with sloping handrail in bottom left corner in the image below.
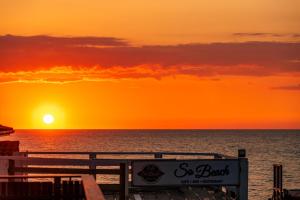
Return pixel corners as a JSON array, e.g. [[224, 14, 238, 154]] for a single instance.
[[0, 175, 105, 200]]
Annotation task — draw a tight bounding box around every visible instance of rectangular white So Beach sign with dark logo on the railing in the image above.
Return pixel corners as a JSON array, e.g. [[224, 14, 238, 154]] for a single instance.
[[132, 160, 239, 186]]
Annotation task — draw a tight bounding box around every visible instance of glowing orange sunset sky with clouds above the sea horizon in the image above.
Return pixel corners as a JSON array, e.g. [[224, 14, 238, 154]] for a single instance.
[[0, 0, 300, 129]]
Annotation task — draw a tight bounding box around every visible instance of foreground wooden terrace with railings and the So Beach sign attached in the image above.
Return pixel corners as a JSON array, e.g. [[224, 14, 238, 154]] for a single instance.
[[0, 141, 248, 200]]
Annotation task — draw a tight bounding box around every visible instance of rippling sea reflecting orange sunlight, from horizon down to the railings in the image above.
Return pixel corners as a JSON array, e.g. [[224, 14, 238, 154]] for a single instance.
[[1, 130, 300, 200]]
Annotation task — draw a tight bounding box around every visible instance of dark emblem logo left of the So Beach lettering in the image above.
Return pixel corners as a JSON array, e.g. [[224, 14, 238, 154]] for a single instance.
[[138, 164, 165, 183]]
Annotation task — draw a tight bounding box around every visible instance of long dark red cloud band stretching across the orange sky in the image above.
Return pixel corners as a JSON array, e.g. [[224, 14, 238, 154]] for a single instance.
[[0, 35, 300, 83]]
